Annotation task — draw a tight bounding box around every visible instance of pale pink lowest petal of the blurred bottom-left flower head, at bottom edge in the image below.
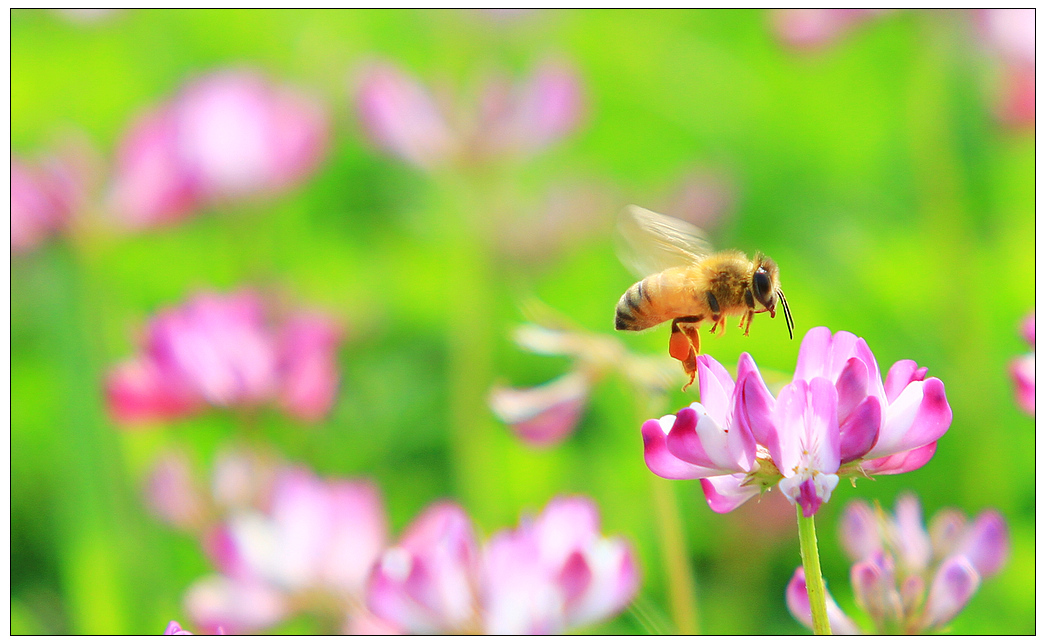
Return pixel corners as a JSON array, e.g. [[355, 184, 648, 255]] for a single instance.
[[184, 575, 290, 635]]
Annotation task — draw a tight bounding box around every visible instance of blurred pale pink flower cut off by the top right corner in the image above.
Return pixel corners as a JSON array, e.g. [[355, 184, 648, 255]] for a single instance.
[[975, 9, 1036, 125]]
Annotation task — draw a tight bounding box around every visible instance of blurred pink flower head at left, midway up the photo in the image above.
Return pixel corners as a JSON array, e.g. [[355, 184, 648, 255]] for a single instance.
[[106, 291, 341, 424]]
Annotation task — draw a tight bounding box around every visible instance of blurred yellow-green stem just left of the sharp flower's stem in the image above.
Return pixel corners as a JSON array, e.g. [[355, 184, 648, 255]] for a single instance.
[[651, 477, 699, 635]]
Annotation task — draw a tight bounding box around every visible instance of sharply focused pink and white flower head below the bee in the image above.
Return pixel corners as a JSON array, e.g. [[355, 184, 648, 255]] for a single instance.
[[642, 327, 952, 516]]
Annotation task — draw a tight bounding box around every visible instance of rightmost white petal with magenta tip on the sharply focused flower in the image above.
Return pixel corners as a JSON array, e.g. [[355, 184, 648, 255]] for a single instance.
[[866, 377, 952, 459]]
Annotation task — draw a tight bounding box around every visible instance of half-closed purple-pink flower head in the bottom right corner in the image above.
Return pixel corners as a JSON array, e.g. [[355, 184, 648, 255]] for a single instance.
[[786, 495, 1009, 635]]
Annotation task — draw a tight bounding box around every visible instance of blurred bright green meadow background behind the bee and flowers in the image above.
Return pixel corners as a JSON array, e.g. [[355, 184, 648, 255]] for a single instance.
[[10, 10, 1036, 634]]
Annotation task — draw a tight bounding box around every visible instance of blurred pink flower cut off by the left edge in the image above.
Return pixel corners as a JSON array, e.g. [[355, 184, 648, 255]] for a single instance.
[[10, 141, 99, 254]]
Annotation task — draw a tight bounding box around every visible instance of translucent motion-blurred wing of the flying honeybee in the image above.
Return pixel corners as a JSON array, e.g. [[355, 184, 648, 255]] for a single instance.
[[617, 205, 712, 277]]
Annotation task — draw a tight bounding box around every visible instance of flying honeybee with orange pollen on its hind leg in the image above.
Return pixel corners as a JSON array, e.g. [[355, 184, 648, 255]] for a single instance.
[[614, 206, 795, 391]]
